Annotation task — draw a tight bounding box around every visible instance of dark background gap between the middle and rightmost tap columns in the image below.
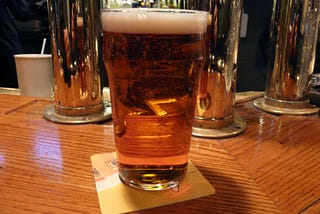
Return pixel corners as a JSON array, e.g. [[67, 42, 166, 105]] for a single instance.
[[237, 0, 273, 91]]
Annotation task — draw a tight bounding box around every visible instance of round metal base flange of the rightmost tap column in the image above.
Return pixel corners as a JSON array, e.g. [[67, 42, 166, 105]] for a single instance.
[[253, 97, 319, 115]]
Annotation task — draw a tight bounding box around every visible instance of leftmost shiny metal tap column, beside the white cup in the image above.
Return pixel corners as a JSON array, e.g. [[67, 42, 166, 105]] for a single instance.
[[45, 0, 110, 122]]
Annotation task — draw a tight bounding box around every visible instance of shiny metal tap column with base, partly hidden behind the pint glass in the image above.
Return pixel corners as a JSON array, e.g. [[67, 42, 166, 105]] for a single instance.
[[189, 0, 246, 138]]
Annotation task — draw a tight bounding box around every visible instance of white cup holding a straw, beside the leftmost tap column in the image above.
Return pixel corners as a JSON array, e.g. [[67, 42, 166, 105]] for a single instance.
[[14, 54, 53, 98]]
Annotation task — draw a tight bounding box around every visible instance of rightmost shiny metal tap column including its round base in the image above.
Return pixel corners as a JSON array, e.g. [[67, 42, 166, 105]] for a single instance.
[[254, 0, 320, 114]]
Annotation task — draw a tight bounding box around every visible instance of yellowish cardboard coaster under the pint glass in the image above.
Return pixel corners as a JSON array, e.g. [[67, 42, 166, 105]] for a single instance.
[[91, 153, 215, 214]]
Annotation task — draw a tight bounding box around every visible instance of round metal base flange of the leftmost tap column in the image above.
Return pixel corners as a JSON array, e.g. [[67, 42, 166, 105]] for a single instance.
[[43, 102, 112, 124]]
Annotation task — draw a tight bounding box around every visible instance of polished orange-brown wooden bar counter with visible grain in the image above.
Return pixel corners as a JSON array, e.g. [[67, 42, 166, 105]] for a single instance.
[[0, 91, 320, 214]]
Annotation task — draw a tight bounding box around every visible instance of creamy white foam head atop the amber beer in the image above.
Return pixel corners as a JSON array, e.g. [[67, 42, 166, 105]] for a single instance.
[[101, 8, 208, 34]]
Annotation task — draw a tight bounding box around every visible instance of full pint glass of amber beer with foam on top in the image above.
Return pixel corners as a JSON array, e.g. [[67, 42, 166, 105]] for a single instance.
[[102, 9, 207, 190]]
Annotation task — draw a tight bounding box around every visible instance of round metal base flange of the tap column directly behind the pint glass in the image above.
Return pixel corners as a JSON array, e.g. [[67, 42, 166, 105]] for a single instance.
[[192, 115, 246, 138]]
